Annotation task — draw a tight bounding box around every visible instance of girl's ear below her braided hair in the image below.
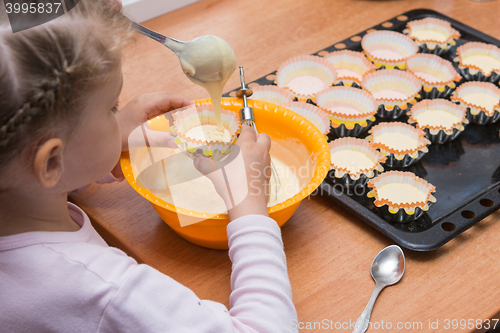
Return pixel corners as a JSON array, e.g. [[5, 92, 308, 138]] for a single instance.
[[33, 138, 63, 188]]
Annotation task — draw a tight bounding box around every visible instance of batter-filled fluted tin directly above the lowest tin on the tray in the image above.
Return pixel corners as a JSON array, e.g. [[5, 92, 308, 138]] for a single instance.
[[366, 122, 431, 168]]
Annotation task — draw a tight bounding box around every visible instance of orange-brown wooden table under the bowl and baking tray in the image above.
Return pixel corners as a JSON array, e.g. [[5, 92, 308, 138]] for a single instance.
[[72, 0, 500, 332]]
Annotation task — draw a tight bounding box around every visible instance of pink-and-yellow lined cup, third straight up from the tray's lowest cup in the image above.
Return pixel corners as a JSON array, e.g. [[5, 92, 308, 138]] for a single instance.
[[363, 69, 422, 119]]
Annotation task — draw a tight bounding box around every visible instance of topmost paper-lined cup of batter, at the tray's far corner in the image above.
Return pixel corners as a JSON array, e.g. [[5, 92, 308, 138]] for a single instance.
[[403, 17, 460, 56]]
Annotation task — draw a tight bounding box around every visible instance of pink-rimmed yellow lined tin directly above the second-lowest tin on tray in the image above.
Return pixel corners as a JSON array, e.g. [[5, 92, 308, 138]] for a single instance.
[[316, 86, 378, 137]]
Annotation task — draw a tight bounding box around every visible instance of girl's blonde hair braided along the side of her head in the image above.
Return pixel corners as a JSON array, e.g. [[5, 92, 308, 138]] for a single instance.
[[0, 0, 131, 170]]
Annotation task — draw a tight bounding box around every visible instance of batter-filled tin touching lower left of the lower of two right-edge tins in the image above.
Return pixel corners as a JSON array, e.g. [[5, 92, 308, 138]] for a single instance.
[[408, 99, 469, 144]]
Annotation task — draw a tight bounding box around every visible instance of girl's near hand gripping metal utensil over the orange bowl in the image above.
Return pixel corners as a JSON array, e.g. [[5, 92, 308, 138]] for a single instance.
[[194, 125, 271, 221]]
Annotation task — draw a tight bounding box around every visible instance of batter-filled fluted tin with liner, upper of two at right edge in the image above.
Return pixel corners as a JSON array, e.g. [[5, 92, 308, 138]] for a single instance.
[[454, 42, 500, 83]]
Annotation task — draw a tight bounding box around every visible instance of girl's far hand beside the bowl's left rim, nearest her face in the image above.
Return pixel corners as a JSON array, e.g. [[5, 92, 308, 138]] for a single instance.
[[116, 92, 194, 151]]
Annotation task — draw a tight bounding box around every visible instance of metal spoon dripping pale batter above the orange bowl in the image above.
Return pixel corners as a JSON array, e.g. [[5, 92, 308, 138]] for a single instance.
[[129, 19, 237, 130]]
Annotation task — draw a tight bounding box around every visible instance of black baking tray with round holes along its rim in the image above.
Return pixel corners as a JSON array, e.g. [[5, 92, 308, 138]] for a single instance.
[[225, 9, 500, 251]]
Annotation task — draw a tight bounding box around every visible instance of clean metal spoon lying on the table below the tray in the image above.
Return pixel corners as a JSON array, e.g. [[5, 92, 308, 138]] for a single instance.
[[352, 245, 405, 333]]
